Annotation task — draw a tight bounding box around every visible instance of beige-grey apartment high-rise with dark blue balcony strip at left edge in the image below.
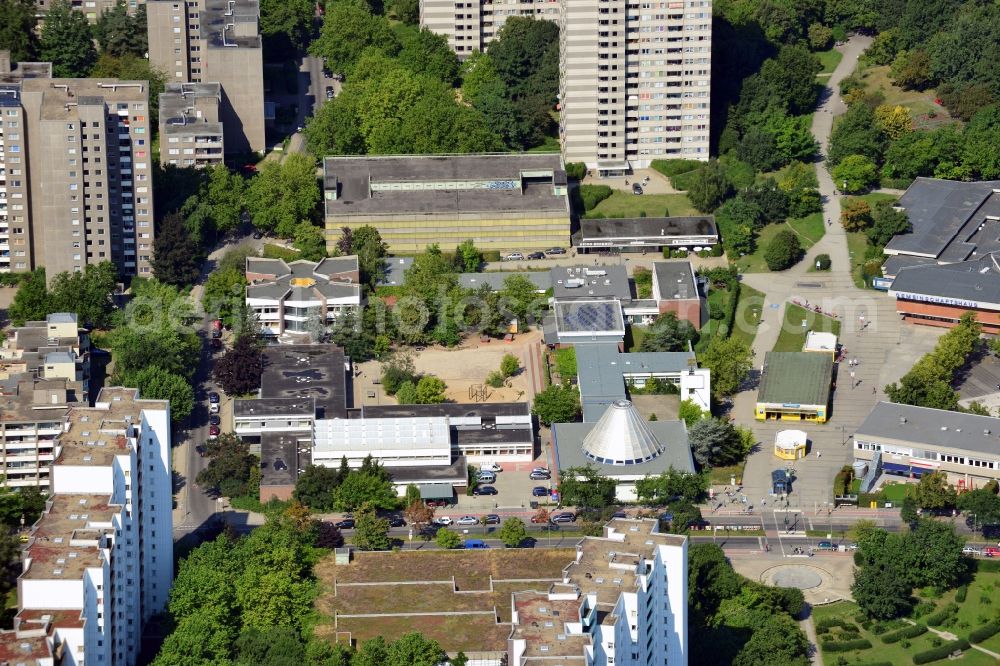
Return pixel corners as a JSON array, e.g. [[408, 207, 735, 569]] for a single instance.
[[0, 52, 153, 278]]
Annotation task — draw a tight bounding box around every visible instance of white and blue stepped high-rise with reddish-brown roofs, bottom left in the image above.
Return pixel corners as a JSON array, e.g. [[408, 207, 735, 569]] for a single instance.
[[0, 388, 173, 666]]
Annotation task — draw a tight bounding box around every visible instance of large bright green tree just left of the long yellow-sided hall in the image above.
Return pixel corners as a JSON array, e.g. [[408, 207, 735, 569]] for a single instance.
[[246, 153, 322, 238]]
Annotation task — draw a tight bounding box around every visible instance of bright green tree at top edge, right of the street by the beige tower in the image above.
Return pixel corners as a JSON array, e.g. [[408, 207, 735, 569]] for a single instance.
[[309, 0, 399, 77]]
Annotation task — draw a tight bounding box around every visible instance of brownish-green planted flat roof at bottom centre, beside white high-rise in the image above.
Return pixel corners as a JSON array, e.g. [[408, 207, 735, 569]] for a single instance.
[[315, 548, 575, 651]]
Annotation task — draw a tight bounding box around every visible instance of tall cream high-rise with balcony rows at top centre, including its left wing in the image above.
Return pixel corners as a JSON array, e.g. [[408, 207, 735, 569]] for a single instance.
[[420, 0, 712, 176]]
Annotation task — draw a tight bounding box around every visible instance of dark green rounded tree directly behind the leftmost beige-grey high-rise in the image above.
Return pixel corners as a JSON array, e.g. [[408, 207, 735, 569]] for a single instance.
[[40, 0, 97, 79]]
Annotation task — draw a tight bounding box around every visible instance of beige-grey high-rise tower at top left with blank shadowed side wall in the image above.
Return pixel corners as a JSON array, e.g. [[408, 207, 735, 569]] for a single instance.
[[146, 0, 264, 153]]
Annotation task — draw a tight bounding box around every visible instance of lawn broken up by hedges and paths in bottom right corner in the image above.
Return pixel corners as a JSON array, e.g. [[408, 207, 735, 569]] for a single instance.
[[812, 572, 1000, 666]]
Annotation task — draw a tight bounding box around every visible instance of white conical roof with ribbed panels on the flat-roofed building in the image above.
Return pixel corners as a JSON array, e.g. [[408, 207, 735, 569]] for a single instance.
[[583, 400, 663, 465]]
